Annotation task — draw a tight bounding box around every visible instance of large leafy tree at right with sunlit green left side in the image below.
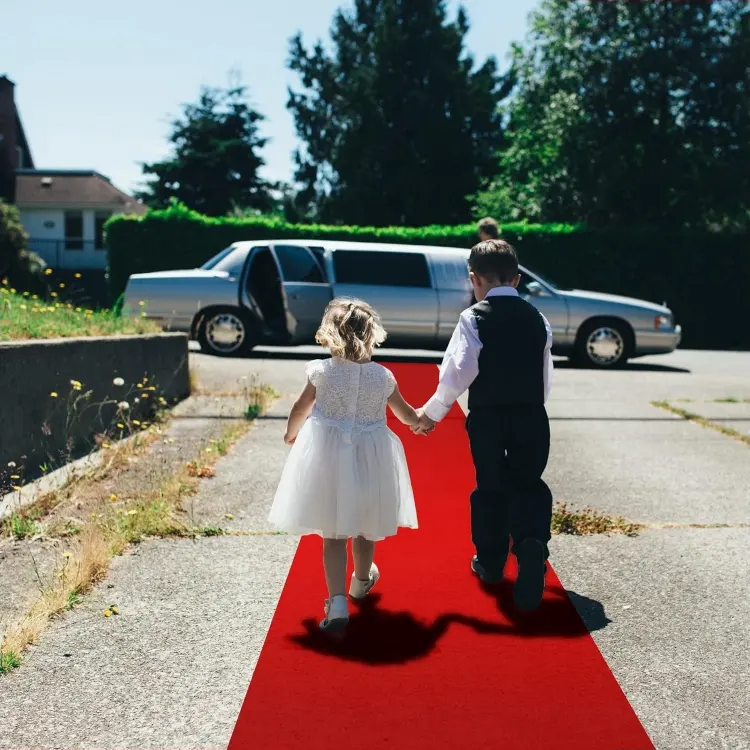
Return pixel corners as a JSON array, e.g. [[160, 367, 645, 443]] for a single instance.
[[476, 0, 750, 225]]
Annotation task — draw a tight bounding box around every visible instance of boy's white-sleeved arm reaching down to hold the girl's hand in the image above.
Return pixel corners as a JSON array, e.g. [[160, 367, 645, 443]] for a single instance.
[[421, 310, 482, 423]]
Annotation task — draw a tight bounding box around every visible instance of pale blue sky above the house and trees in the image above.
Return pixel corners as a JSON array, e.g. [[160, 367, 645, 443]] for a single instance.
[[0, 0, 537, 197]]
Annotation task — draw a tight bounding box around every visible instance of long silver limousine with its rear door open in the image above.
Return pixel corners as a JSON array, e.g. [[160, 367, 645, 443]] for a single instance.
[[124, 239, 681, 368]]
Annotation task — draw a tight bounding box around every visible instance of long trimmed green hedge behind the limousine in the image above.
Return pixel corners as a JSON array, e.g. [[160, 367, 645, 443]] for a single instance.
[[107, 206, 750, 349]]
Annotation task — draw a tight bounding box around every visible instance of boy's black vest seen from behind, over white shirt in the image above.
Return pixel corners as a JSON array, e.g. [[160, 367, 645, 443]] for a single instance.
[[469, 296, 547, 411]]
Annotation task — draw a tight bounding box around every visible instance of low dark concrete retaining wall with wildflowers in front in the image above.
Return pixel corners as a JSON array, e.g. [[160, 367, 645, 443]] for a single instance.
[[0, 333, 190, 482]]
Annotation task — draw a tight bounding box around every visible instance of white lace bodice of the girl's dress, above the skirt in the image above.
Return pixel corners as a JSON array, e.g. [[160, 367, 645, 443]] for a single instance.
[[306, 358, 396, 432]]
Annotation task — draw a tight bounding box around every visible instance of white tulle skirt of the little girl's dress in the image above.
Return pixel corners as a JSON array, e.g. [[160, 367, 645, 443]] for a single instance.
[[269, 417, 417, 541]]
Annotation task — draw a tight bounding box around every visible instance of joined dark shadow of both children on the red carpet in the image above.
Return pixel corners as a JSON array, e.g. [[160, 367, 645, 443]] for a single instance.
[[289, 592, 612, 664]]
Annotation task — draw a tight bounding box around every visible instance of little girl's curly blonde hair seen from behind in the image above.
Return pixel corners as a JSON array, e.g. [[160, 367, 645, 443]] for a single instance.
[[315, 297, 386, 362]]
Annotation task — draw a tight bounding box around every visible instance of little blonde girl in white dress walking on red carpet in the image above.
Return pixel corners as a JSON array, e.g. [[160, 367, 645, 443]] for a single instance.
[[269, 299, 418, 631]]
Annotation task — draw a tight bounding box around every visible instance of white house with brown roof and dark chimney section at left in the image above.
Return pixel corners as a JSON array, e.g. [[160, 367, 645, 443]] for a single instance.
[[0, 76, 146, 271]]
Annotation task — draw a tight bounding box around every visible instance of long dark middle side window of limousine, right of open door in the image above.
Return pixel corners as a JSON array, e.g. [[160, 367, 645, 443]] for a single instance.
[[333, 250, 432, 288]]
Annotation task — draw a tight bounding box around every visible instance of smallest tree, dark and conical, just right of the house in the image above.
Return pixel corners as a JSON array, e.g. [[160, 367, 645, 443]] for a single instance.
[[139, 86, 273, 216]]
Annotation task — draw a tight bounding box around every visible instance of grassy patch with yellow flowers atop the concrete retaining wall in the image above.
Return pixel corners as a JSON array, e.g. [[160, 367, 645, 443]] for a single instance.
[[0, 282, 161, 341]]
